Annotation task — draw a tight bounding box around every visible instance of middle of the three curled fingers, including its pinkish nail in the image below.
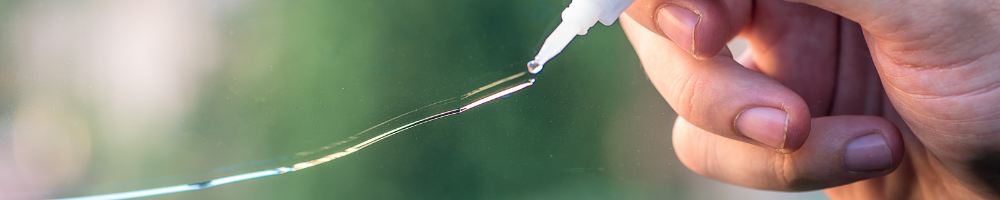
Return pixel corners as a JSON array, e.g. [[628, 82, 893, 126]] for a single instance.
[[620, 14, 810, 153]]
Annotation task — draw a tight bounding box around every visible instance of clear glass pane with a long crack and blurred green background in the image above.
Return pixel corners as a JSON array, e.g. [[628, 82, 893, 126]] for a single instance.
[[0, 0, 824, 199]]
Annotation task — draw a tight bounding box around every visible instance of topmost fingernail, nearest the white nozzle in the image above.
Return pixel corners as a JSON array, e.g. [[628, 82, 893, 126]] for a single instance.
[[656, 5, 701, 55]]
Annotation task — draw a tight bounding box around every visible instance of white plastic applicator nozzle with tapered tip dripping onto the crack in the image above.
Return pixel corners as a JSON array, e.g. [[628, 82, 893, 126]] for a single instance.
[[528, 0, 635, 74]]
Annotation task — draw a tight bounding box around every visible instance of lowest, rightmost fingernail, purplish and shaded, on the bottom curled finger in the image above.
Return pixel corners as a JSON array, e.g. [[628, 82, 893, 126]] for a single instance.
[[844, 133, 892, 172]]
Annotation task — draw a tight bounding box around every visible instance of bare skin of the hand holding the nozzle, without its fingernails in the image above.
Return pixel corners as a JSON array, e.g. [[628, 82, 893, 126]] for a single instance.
[[620, 0, 1000, 199]]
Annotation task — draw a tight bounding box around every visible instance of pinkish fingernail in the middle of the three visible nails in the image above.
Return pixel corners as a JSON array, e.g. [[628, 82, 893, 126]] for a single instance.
[[736, 107, 788, 150]]
